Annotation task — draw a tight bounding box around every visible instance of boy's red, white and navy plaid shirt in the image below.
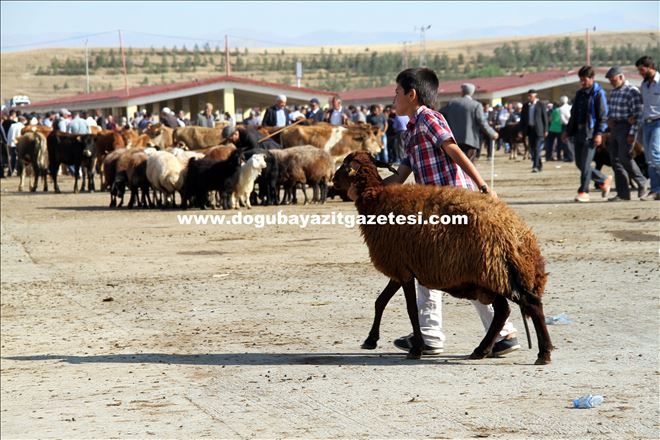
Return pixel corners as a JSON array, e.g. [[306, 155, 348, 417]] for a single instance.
[[402, 106, 477, 191]]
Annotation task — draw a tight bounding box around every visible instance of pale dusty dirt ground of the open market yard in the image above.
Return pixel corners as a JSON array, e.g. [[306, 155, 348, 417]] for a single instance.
[[0, 154, 660, 439]]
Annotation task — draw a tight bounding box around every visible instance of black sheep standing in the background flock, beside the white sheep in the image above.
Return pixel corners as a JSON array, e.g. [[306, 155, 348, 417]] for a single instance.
[[180, 151, 241, 209]]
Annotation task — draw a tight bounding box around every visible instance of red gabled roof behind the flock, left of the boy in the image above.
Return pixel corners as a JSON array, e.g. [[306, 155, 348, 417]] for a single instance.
[[30, 76, 336, 106]]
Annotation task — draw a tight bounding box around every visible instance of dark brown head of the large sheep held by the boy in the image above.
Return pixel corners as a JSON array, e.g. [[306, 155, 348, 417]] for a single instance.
[[332, 151, 396, 200]]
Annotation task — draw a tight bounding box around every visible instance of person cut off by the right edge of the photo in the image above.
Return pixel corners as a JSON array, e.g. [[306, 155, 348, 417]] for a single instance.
[[635, 56, 660, 200]]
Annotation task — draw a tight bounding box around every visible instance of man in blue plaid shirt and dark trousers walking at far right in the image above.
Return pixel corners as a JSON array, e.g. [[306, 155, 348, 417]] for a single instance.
[[605, 66, 648, 202]]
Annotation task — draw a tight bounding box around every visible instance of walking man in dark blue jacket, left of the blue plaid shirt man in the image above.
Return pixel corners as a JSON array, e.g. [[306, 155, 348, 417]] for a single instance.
[[562, 66, 612, 203]]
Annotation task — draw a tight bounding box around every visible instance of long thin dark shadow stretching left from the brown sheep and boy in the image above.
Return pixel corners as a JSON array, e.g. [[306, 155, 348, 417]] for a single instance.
[[1, 352, 488, 366]]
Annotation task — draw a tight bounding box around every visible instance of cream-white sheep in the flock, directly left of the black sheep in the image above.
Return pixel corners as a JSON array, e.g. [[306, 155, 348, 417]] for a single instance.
[[146, 151, 185, 207]]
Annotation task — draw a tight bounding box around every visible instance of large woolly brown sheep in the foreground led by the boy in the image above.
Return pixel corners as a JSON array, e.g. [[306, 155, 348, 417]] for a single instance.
[[334, 152, 553, 365]]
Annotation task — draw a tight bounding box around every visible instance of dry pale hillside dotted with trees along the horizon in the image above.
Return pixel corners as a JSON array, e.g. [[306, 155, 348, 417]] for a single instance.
[[0, 31, 660, 102]]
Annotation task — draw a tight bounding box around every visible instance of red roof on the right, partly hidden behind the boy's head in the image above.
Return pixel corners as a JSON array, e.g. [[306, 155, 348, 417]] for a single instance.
[[340, 70, 588, 101]]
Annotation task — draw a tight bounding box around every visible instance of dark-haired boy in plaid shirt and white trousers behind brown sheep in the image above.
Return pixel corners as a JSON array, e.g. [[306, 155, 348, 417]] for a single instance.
[[385, 68, 520, 356]]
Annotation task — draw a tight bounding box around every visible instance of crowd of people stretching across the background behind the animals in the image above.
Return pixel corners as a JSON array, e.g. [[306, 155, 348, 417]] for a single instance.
[[0, 57, 660, 202]]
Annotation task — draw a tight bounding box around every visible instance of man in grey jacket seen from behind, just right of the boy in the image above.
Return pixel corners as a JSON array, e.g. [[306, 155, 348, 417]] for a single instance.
[[440, 84, 498, 162]]
